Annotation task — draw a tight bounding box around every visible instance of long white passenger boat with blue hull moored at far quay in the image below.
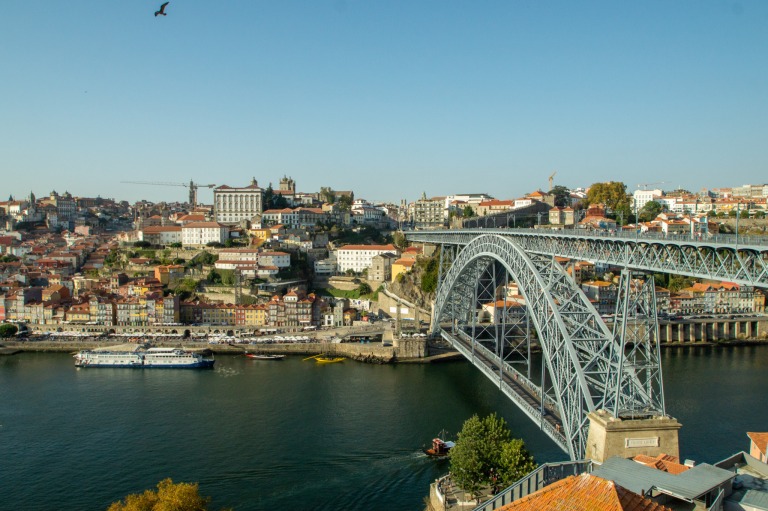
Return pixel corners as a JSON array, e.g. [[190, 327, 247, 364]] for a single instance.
[[75, 345, 214, 369]]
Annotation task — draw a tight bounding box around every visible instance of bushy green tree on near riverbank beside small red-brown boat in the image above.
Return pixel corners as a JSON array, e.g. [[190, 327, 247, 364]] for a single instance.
[[450, 414, 536, 496]]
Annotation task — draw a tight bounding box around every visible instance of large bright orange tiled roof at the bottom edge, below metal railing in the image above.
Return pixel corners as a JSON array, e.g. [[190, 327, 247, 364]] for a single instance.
[[499, 474, 672, 511]]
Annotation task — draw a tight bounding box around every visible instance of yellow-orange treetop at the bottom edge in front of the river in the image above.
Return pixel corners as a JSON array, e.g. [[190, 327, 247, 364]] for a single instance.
[[107, 478, 230, 511]]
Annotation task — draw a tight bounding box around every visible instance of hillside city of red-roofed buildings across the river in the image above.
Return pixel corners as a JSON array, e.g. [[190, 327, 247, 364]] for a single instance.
[[0, 178, 768, 332]]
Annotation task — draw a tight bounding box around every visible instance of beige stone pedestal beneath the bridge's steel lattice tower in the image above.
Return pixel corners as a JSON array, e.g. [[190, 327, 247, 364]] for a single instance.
[[586, 410, 682, 463]]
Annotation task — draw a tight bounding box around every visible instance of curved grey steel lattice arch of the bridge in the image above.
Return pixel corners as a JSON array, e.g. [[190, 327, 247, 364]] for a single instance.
[[433, 234, 620, 459]]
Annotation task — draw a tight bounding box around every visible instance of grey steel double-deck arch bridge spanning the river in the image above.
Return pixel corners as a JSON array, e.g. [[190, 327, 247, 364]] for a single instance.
[[405, 229, 768, 460]]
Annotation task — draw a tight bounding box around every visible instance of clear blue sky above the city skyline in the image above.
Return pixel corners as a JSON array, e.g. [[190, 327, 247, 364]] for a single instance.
[[0, 0, 768, 206]]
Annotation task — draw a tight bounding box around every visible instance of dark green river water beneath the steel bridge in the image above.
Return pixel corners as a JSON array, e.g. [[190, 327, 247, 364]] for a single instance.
[[0, 347, 768, 511]]
